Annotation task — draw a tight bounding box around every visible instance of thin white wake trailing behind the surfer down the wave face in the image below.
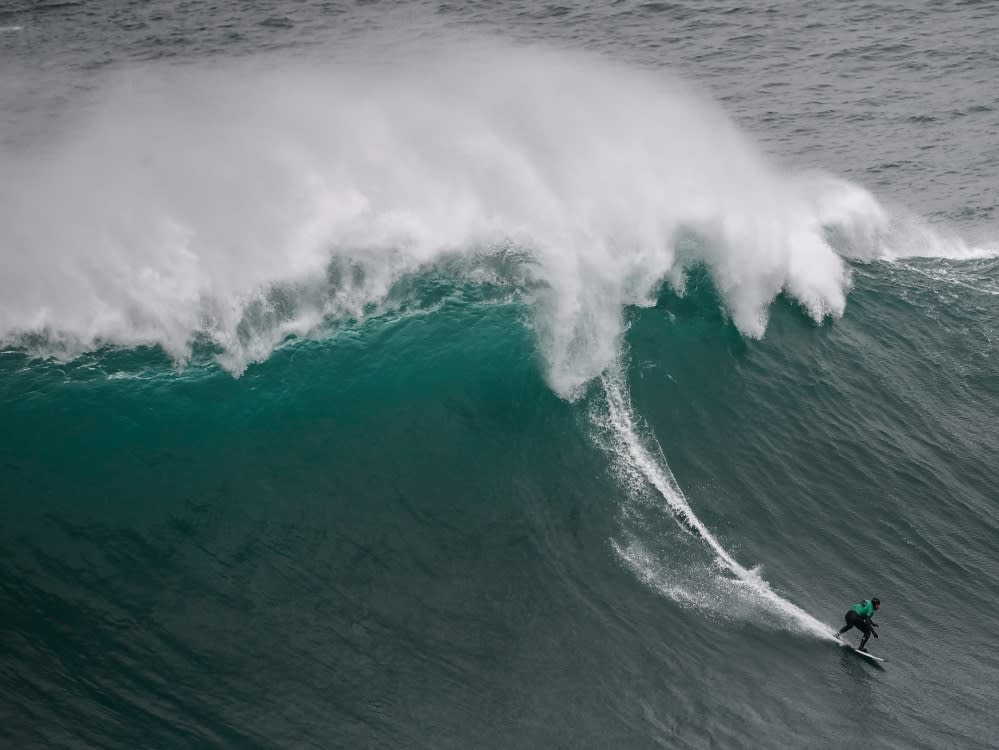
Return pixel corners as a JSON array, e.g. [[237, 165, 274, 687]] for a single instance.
[[591, 362, 835, 641]]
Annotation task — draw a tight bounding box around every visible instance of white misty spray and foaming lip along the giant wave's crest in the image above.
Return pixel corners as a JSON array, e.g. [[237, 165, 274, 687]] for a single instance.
[[0, 40, 976, 396]]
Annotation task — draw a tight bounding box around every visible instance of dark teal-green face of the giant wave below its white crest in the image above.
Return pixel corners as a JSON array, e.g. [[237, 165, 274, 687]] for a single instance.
[[0, 260, 999, 747]]
